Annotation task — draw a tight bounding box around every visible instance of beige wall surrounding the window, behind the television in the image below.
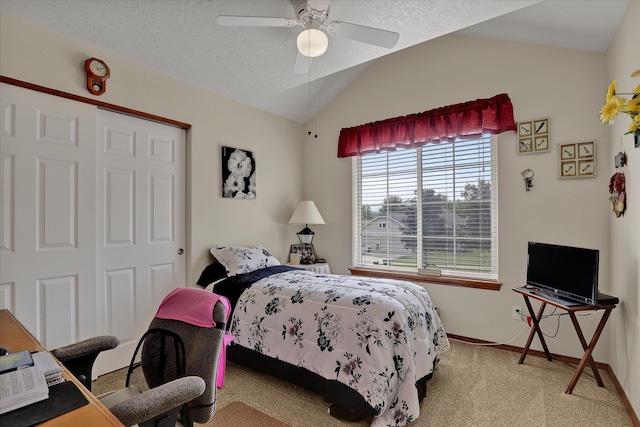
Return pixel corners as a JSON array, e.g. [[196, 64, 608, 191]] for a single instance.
[[304, 35, 620, 362]]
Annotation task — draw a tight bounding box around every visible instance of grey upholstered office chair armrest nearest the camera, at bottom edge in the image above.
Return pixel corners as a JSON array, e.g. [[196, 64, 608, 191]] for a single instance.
[[109, 376, 206, 426]]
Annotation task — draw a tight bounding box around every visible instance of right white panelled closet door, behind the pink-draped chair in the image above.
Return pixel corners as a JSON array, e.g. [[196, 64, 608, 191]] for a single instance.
[[94, 110, 186, 375]]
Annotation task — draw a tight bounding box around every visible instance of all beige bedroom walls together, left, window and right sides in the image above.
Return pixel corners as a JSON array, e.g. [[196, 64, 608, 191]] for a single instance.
[[0, 2, 640, 418]]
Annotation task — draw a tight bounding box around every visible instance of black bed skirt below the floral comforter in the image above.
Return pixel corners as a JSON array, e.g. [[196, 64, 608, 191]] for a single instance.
[[227, 344, 433, 421]]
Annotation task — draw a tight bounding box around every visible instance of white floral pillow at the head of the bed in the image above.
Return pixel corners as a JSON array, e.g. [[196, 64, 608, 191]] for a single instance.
[[211, 246, 280, 276]]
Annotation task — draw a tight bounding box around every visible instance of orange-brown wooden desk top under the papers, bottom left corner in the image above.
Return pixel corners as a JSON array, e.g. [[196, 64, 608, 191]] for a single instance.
[[0, 310, 123, 427]]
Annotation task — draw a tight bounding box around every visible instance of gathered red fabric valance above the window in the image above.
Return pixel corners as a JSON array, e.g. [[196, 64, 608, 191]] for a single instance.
[[338, 93, 516, 157]]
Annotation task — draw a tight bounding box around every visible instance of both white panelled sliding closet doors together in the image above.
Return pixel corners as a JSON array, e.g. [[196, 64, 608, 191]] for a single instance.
[[0, 84, 187, 375]]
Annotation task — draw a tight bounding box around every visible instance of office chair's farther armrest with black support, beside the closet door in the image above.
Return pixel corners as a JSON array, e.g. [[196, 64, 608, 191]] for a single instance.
[[51, 335, 120, 391]]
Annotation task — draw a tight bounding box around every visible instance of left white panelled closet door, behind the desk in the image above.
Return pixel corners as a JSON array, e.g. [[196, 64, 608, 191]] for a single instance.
[[0, 84, 99, 348]]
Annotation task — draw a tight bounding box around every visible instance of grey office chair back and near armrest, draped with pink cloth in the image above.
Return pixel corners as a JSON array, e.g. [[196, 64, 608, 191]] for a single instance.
[[99, 288, 229, 427]]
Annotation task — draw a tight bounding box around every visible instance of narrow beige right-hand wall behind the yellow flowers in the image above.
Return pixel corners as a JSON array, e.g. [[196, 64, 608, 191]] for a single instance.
[[606, 1, 640, 416]]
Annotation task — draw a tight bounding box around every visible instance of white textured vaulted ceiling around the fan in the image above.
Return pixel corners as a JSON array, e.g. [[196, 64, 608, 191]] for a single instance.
[[0, 0, 628, 123]]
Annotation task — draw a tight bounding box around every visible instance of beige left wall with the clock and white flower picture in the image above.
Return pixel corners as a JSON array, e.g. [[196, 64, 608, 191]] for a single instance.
[[0, 14, 302, 284]]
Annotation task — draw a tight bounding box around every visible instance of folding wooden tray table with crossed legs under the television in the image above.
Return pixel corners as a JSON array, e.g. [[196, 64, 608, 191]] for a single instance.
[[513, 288, 616, 394]]
